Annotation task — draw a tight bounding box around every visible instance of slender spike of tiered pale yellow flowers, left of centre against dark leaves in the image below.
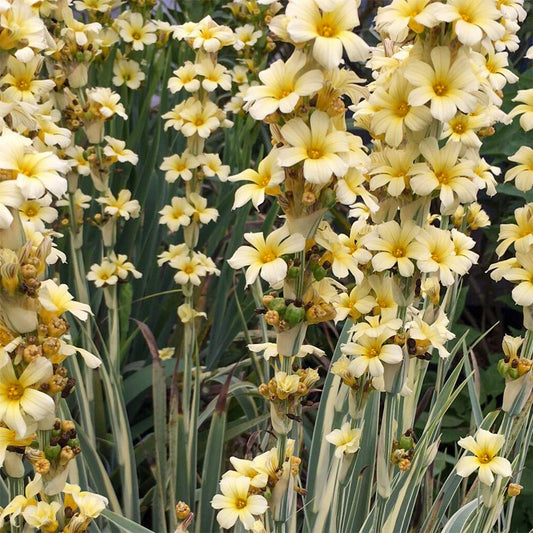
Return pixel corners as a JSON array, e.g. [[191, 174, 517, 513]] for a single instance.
[[158, 16, 235, 316]]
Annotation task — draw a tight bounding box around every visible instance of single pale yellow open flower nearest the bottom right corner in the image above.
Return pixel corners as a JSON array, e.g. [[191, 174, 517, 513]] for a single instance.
[[455, 429, 513, 485]]
